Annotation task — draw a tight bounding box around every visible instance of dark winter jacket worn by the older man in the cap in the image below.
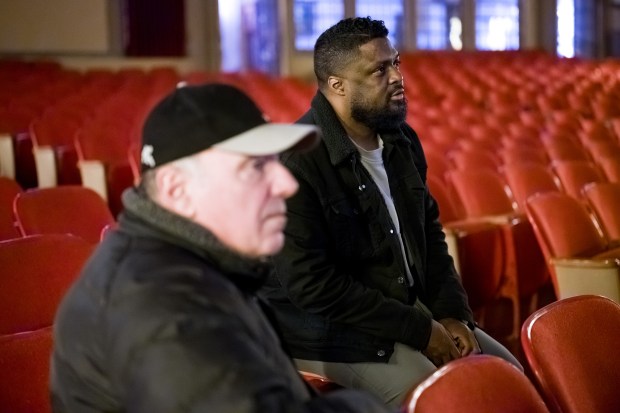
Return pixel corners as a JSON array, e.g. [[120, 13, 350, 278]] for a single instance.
[[51, 190, 392, 413]]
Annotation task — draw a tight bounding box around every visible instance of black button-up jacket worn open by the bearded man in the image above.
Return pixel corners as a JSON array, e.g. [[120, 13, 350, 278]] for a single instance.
[[263, 92, 472, 362]]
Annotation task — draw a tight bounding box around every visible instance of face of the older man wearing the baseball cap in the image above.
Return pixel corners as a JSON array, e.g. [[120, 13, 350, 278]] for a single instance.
[[190, 149, 298, 257]]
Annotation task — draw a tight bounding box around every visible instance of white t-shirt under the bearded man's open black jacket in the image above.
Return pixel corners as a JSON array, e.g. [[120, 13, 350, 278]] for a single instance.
[[351, 135, 413, 286]]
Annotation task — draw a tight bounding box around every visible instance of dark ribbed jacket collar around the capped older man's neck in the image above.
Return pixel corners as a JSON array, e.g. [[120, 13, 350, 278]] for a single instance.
[[119, 188, 270, 292]]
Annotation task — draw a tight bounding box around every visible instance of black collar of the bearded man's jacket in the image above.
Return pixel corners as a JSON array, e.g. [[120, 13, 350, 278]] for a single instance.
[[311, 91, 409, 165]]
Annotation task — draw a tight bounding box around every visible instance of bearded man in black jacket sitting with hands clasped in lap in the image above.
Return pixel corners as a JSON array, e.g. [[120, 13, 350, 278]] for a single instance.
[[262, 17, 522, 406]]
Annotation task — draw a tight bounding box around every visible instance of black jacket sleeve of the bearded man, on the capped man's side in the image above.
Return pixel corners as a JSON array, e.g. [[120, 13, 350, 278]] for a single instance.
[[274, 167, 431, 349]]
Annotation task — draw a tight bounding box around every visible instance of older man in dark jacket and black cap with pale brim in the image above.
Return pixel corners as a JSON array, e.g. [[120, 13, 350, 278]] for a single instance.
[[51, 84, 385, 413]]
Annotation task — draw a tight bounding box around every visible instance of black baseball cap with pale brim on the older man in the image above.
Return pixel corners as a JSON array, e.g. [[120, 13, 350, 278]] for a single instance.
[[141, 83, 321, 171]]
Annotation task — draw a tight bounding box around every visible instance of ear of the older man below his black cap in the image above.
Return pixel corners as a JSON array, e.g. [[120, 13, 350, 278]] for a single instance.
[[155, 165, 195, 218]]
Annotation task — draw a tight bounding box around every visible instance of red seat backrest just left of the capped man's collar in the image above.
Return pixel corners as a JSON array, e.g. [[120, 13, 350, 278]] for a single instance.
[[13, 185, 115, 243]]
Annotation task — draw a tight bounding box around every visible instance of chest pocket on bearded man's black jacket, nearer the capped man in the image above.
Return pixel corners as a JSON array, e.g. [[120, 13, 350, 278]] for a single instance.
[[326, 198, 374, 258]]
